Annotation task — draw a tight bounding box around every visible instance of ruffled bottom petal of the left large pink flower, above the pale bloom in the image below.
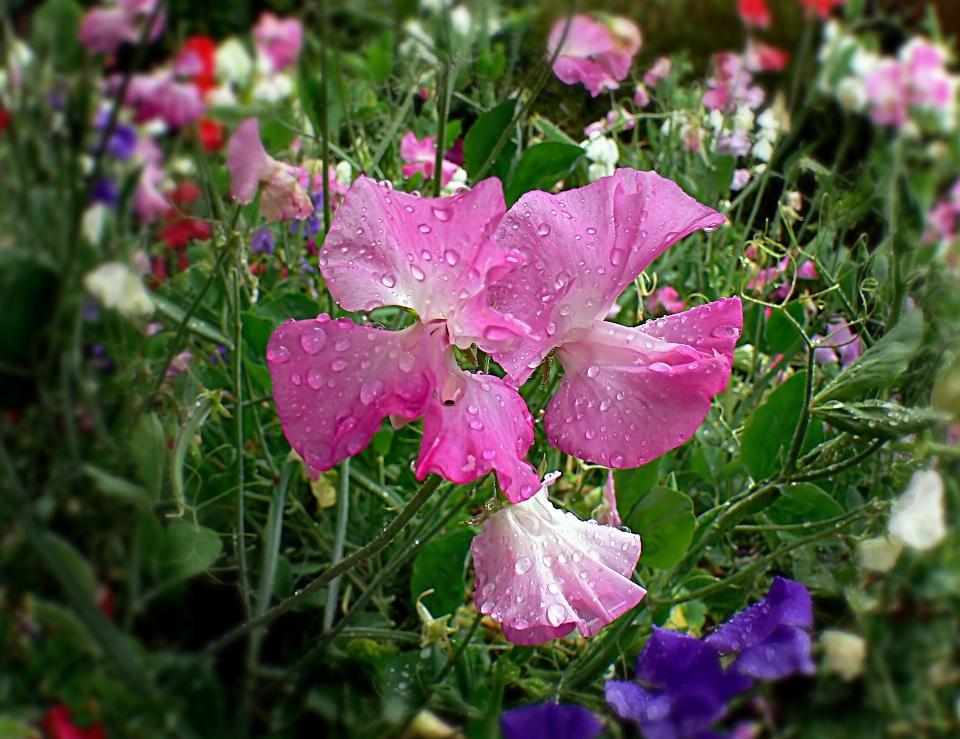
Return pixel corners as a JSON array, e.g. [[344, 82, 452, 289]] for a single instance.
[[417, 367, 540, 502]]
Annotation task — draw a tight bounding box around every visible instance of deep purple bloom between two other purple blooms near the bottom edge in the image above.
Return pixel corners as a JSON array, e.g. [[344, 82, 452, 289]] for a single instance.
[[605, 626, 751, 739]]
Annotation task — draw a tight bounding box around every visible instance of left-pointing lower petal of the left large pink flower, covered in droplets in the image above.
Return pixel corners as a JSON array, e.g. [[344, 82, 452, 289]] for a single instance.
[[267, 315, 435, 470]]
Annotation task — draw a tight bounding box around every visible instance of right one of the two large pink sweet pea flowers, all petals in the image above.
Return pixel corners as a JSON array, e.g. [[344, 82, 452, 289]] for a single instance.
[[459, 169, 743, 468]]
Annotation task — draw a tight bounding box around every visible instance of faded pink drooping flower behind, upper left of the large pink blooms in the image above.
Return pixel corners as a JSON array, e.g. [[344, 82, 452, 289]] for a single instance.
[[227, 118, 313, 223]]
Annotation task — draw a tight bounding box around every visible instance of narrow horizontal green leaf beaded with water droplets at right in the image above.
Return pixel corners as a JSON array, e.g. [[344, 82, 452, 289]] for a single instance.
[[810, 400, 950, 441]]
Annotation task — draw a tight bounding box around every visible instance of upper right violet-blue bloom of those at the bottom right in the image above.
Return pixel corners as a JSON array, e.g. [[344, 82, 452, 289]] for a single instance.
[[705, 577, 817, 680]]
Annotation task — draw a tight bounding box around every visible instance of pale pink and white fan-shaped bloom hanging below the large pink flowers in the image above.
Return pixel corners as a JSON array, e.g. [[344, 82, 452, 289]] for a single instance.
[[470, 473, 646, 646]]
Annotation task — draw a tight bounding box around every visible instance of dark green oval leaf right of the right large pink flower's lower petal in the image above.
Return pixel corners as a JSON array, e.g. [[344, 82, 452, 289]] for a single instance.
[[740, 372, 807, 480]]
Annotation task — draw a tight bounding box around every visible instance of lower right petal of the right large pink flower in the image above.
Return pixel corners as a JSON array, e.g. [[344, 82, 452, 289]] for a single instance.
[[544, 298, 743, 468]]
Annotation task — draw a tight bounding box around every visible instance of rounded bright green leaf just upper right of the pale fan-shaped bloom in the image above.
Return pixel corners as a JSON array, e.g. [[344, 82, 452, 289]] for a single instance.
[[623, 486, 696, 569]]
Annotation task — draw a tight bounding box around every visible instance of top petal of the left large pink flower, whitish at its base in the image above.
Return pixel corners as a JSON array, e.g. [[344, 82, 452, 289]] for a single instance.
[[320, 177, 519, 322]]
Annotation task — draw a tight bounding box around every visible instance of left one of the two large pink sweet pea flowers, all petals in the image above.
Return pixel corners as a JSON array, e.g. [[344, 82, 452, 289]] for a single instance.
[[267, 177, 539, 501]]
